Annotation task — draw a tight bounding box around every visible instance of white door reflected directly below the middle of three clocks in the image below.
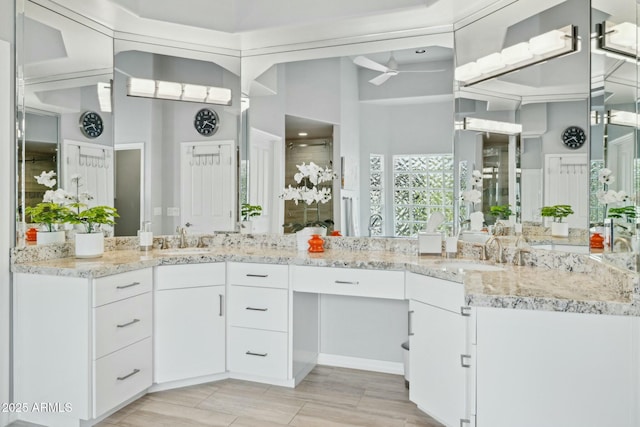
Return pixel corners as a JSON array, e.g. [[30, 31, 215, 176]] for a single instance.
[[180, 141, 236, 233]]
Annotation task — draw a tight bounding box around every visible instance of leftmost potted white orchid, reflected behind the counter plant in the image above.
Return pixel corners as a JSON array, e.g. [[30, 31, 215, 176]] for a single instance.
[[25, 171, 71, 245]]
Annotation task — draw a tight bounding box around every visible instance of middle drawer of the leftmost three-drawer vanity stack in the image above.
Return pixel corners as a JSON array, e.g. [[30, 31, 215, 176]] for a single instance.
[[94, 292, 153, 359]]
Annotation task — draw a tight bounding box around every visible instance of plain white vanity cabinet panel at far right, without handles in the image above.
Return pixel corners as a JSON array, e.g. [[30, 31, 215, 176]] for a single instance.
[[477, 308, 640, 427]]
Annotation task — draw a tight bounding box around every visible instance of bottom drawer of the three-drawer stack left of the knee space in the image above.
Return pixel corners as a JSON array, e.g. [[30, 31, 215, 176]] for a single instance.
[[229, 327, 287, 379]]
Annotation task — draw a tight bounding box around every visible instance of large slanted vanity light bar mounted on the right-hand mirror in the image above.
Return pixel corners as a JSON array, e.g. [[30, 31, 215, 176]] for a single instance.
[[455, 25, 579, 86]]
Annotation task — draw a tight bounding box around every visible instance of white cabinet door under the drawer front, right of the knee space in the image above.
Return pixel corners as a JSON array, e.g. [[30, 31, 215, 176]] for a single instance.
[[409, 300, 468, 426]]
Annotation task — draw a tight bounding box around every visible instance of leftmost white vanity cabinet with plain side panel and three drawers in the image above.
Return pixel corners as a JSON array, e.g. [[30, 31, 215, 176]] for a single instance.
[[13, 269, 152, 427]]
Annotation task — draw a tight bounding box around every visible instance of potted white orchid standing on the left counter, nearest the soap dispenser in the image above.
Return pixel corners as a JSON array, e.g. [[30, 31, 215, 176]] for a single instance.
[[68, 175, 119, 258]]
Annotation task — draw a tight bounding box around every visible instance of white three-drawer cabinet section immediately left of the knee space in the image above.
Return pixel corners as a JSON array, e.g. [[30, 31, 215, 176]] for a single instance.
[[227, 262, 290, 383]]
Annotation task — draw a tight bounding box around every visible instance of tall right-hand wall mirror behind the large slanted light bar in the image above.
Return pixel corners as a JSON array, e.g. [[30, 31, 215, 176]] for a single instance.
[[455, 0, 590, 245]]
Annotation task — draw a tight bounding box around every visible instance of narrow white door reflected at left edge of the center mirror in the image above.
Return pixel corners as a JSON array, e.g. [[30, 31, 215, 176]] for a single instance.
[[249, 128, 284, 233]]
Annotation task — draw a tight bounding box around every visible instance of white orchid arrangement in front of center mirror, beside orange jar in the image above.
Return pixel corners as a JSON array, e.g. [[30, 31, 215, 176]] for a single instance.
[[280, 162, 336, 250]]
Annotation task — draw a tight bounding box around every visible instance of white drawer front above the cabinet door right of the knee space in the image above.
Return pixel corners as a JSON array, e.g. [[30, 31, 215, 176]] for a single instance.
[[407, 273, 465, 313]]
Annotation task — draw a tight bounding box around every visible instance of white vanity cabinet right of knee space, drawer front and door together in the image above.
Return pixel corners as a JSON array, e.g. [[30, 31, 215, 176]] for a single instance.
[[406, 273, 473, 427]]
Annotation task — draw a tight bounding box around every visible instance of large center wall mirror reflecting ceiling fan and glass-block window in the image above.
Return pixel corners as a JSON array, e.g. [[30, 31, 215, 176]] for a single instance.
[[242, 33, 454, 236]]
